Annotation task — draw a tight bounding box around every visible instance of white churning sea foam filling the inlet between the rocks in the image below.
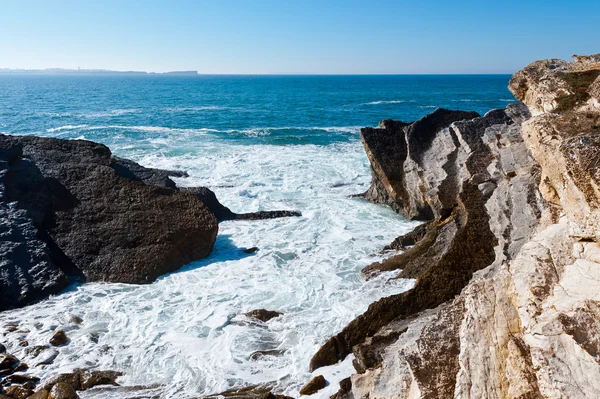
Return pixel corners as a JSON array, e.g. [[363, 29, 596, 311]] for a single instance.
[[0, 139, 414, 398]]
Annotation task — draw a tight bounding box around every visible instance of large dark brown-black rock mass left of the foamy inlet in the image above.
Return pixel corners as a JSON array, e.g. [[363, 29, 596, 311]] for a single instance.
[[0, 135, 217, 309]]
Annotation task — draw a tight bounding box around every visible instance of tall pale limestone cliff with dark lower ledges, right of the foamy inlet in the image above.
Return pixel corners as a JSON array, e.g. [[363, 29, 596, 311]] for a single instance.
[[311, 55, 600, 399]]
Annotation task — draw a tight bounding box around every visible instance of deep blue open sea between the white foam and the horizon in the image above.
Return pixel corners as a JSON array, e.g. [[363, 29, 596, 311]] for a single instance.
[[0, 75, 514, 145]]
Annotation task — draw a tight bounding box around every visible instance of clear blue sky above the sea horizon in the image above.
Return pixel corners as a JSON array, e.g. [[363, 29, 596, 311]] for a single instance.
[[0, 0, 600, 73]]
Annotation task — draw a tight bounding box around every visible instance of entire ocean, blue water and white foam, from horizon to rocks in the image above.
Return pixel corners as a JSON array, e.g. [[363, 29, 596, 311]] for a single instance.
[[0, 75, 514, 398]]
